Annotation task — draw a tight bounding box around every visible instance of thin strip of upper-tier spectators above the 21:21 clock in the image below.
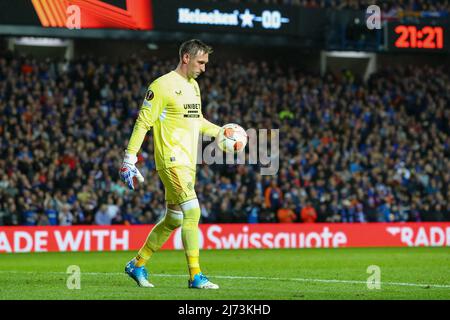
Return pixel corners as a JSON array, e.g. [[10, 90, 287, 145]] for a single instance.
[[223, 0, 450, 16]]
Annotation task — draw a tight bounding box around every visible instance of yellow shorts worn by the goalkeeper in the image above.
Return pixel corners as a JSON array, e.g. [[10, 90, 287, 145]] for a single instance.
[[158, 167, 197, 204]]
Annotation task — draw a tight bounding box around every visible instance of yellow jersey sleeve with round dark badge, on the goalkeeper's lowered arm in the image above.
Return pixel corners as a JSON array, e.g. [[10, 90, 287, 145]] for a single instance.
[[127, 81, 167, 155]]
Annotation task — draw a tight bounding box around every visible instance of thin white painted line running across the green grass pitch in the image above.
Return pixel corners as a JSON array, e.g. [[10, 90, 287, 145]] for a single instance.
[[0, 270, 450, 289]]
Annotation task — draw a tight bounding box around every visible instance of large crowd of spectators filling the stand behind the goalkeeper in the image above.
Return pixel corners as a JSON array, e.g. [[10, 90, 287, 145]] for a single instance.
[[0, 49, 450, 225]]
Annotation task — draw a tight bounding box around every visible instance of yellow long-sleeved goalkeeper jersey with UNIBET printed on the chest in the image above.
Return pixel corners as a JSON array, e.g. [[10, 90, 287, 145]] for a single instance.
[[127, 71, 220, 170]]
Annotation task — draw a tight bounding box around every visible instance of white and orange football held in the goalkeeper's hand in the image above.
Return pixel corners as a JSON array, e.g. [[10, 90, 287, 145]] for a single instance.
[[216, 123, 248, 153]]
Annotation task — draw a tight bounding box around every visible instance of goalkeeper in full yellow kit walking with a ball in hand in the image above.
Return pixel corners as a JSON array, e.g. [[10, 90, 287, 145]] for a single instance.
[[119, 39, 224, 289]]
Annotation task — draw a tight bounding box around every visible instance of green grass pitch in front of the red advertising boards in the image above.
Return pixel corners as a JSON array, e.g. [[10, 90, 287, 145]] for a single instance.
[[0, 247, 450, 300]]
